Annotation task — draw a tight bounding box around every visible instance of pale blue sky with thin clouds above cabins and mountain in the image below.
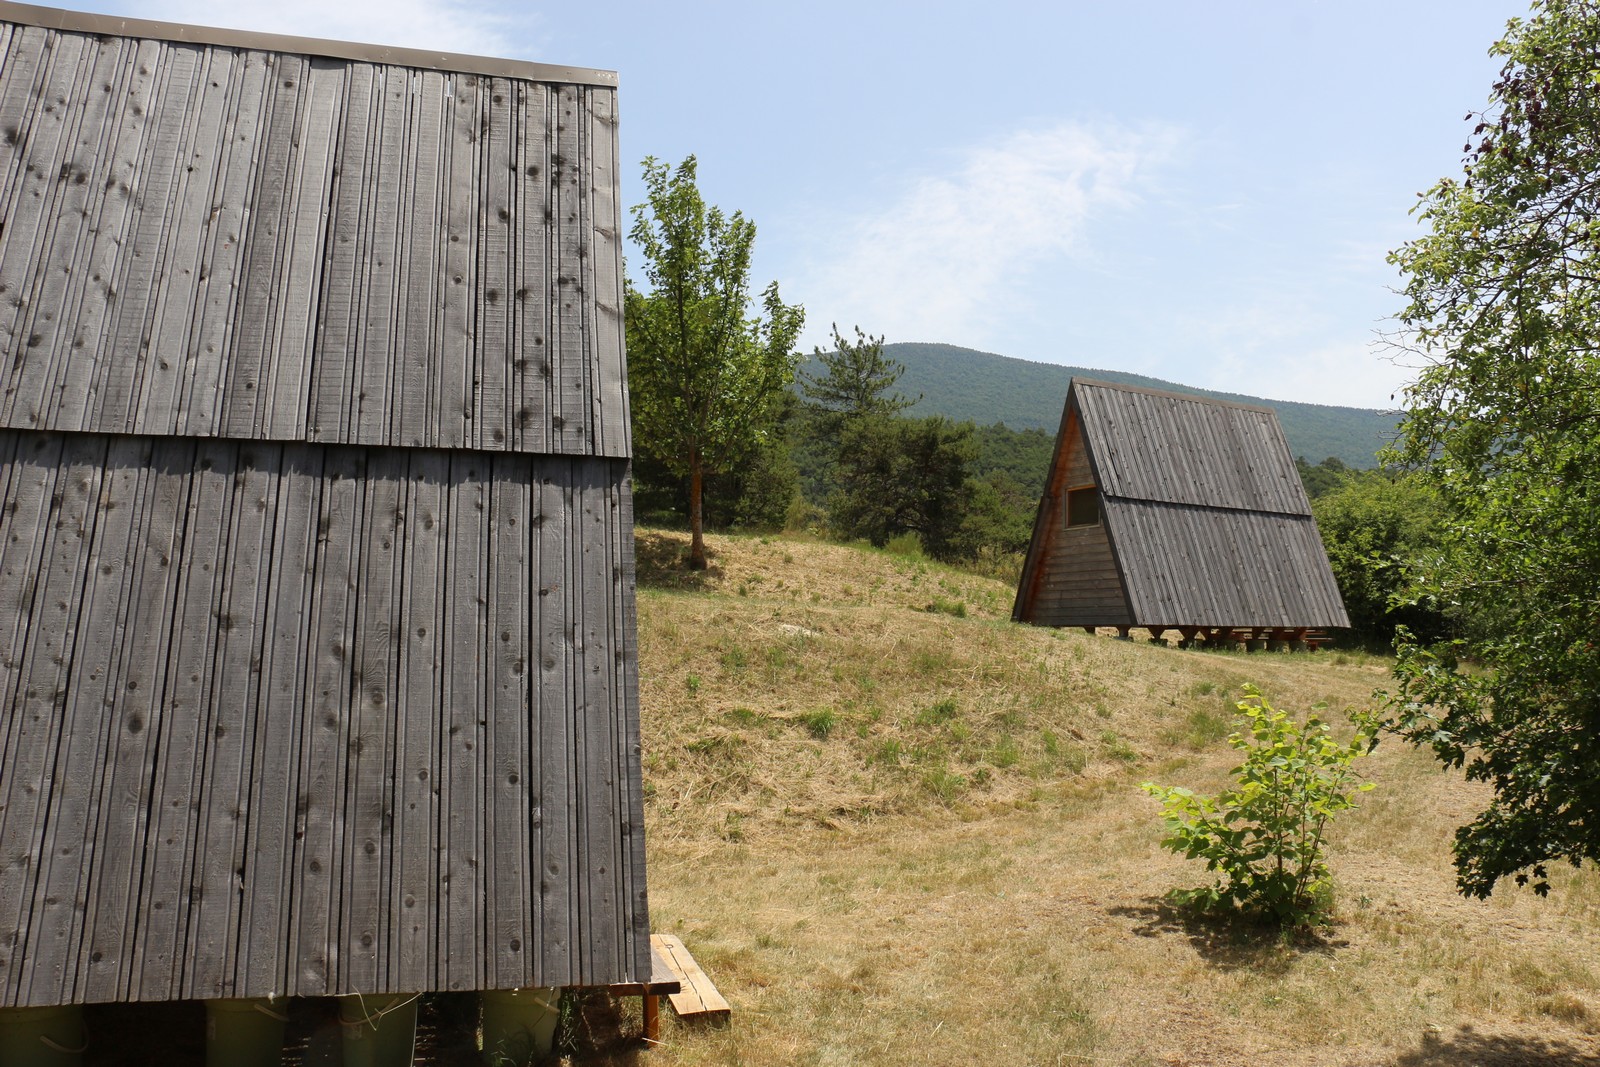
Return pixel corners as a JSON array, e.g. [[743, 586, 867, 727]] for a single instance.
[[90, 0, 1526, 408]]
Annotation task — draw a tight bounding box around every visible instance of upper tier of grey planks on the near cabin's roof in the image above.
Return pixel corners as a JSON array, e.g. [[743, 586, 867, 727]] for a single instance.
[[0, 14, 629, 456]]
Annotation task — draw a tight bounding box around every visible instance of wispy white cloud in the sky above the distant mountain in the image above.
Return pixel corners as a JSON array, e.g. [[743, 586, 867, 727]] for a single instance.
[[786, 123, 1182, 347]]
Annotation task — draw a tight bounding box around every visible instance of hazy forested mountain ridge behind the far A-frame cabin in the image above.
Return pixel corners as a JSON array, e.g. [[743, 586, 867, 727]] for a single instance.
[[883, 342, 1398, 467]]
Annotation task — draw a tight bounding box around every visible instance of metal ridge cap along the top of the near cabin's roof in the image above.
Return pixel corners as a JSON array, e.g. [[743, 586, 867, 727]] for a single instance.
[[0, 0, 618, 88]]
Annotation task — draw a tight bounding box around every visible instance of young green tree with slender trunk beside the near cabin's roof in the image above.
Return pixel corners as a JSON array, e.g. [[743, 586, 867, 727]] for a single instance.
[[626, 155, 805, 566]]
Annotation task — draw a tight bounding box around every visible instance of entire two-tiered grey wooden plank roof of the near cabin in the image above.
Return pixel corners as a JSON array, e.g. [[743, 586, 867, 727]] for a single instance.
[[0, 2, 650, 1006]]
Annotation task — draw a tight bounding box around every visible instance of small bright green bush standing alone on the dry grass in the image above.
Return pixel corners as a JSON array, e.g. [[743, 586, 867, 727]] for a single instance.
[[1141, 686, 1376, 928]]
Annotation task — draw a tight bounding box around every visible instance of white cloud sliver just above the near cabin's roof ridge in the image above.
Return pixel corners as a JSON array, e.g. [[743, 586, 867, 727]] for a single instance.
[[126, 0, 538, 58]]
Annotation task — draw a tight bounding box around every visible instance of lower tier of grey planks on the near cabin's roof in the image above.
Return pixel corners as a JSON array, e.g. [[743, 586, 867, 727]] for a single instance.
[[0, 432, 648, 1006]]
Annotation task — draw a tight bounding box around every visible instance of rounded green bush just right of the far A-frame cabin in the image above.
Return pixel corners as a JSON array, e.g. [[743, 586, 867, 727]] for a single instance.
[[1310, 472, 1446, 648]]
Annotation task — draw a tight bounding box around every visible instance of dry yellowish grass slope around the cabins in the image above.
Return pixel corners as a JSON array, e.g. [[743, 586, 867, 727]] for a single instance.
[[574, 531, 1600, 1067]]
